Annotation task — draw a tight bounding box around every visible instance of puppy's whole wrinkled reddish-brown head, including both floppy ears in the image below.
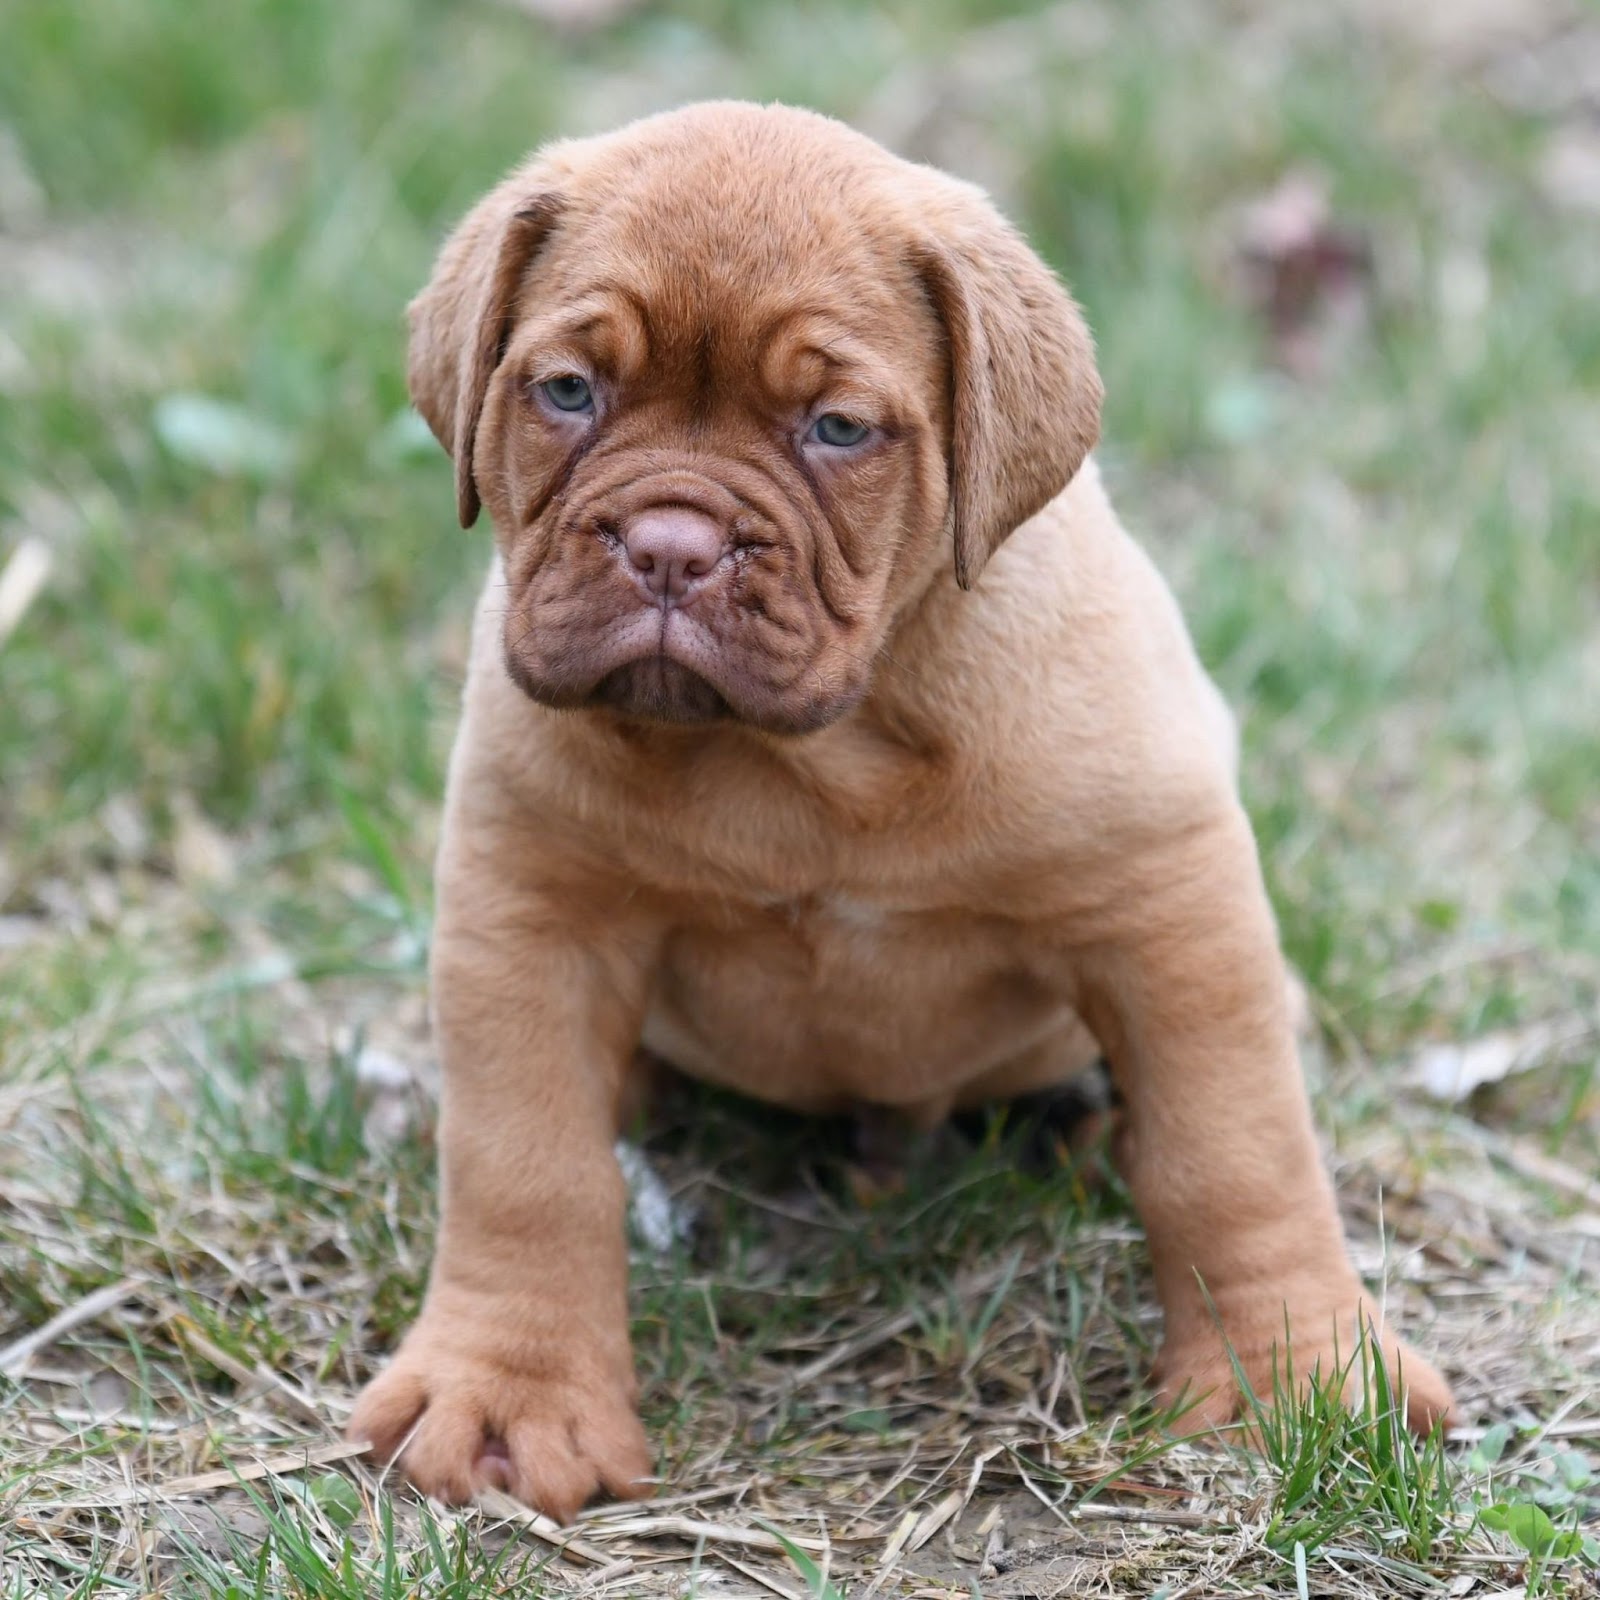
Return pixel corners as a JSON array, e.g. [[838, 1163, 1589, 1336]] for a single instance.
[[411, 104, 1101, 733]]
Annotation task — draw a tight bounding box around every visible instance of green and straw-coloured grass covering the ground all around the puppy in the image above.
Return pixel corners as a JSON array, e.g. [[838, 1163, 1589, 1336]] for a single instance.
[[0, 0, 1600, 1600]]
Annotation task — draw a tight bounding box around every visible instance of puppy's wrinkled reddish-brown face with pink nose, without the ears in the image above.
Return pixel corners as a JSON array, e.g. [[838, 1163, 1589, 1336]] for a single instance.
[[477, 171, 947, 733]]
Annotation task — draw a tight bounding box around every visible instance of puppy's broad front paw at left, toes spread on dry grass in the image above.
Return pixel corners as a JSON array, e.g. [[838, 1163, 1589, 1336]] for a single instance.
[[347, 1309, 653, 1522]]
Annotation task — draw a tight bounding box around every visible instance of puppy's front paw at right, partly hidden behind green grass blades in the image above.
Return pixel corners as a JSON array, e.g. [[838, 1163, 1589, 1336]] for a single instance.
[[1152, 1301, 1459, 1437]]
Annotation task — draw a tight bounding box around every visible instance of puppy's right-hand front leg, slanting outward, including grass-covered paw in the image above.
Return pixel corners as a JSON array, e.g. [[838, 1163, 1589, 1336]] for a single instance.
[[1080, 808, 1451, 1430]]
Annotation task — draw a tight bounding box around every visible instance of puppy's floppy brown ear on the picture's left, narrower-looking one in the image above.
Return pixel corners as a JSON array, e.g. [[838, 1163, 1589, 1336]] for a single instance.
[[406, 186, 562, 528]]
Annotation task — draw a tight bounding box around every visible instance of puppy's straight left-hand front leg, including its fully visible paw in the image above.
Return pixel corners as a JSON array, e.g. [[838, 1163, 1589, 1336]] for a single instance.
[[349, 816, 651, 1522]]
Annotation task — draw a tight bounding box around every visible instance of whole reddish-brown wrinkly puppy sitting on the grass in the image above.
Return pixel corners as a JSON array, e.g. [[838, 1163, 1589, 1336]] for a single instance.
[[350, 93, 1450, 1518]]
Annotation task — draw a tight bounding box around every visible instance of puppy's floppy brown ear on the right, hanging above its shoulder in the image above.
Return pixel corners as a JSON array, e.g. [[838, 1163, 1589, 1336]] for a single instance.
[[917, 209, 1102, 589]]
